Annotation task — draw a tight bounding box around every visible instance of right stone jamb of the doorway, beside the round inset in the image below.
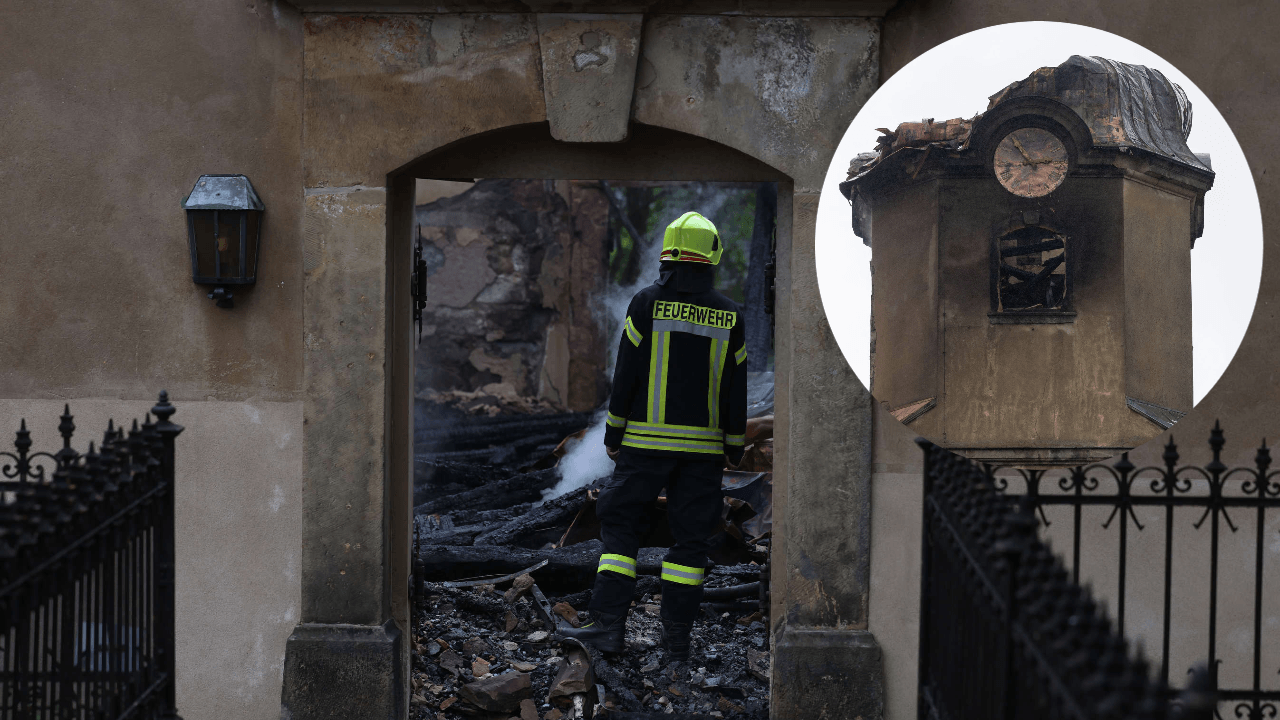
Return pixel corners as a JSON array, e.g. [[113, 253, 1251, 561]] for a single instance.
[[769, 192, 884, 720]]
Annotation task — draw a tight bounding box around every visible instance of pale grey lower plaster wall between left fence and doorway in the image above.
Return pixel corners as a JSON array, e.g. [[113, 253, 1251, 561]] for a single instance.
[[0, 397, 302, 720]]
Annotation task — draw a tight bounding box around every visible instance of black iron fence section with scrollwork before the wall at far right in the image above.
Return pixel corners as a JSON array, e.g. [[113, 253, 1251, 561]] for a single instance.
[[984, 424, 1280, 720]]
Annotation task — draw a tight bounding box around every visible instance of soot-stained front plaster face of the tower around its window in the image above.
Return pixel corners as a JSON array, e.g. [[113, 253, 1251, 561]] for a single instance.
[[936, 178, 1146, 457]]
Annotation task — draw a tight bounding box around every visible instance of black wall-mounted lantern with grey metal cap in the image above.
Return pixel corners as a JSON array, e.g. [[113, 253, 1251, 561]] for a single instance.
[[182, 176, 265, 307]]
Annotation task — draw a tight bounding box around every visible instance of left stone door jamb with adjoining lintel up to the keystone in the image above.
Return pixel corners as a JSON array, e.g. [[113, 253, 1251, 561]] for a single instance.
[[282, 14, 547, 720]]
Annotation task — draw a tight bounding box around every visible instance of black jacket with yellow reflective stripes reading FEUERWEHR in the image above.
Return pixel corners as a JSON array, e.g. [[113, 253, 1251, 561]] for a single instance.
[[604, 261, 746, 465]]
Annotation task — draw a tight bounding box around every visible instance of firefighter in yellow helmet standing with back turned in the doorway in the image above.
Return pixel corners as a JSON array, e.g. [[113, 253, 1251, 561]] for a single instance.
[[562, 213, 746, 661]]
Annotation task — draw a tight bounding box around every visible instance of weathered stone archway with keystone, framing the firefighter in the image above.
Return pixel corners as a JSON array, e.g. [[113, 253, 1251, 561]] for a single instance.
[[284, 14, 879, 717]]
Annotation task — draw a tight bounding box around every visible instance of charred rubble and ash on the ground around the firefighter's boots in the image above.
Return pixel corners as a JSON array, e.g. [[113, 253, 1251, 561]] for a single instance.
[[410, 565, 769, 720]]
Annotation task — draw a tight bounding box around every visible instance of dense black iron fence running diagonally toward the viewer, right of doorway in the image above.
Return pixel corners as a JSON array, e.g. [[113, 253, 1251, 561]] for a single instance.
[[918, 439, 1213, 720]]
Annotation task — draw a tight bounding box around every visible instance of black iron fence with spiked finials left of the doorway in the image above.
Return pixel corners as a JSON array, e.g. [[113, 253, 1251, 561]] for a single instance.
[[0, 392, 183, 720]]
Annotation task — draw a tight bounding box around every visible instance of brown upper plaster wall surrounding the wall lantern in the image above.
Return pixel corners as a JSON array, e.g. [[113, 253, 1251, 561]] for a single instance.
[[0, 0, 302, 402]]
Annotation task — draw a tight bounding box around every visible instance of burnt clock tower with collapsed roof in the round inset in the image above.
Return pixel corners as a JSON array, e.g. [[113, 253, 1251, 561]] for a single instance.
[[841, 55, 1213, 466]]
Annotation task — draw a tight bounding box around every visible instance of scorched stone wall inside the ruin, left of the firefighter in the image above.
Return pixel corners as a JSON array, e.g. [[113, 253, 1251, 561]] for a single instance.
[[415, 179, 608, 410]]
